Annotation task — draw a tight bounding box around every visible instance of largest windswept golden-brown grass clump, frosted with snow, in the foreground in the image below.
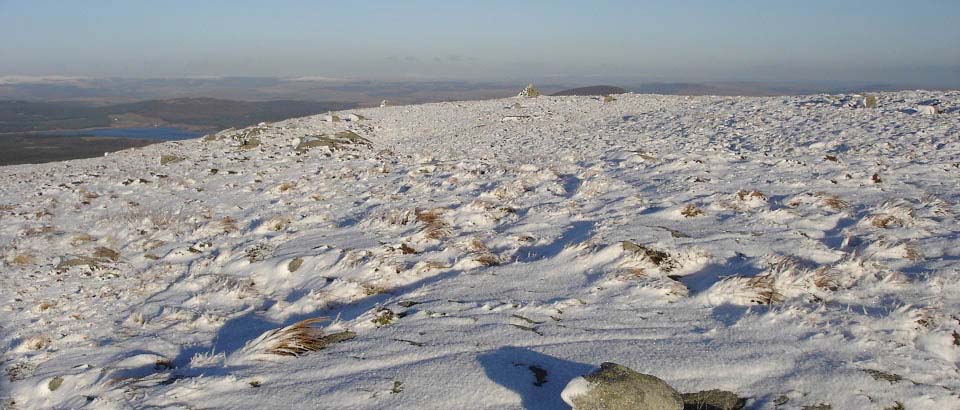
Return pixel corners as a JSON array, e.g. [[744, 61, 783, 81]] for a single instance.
[[243, 318, 357, 357]]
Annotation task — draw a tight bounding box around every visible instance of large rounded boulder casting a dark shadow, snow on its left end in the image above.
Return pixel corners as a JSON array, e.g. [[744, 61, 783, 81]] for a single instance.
[[560, 363, 683, 410]]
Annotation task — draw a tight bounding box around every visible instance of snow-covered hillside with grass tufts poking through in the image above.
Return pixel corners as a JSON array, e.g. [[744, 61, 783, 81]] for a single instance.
[[0, 92, 960, 410]]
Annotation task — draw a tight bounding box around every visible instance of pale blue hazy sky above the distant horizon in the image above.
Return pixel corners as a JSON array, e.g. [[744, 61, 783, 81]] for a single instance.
[[0, 0, 960, 84]]
